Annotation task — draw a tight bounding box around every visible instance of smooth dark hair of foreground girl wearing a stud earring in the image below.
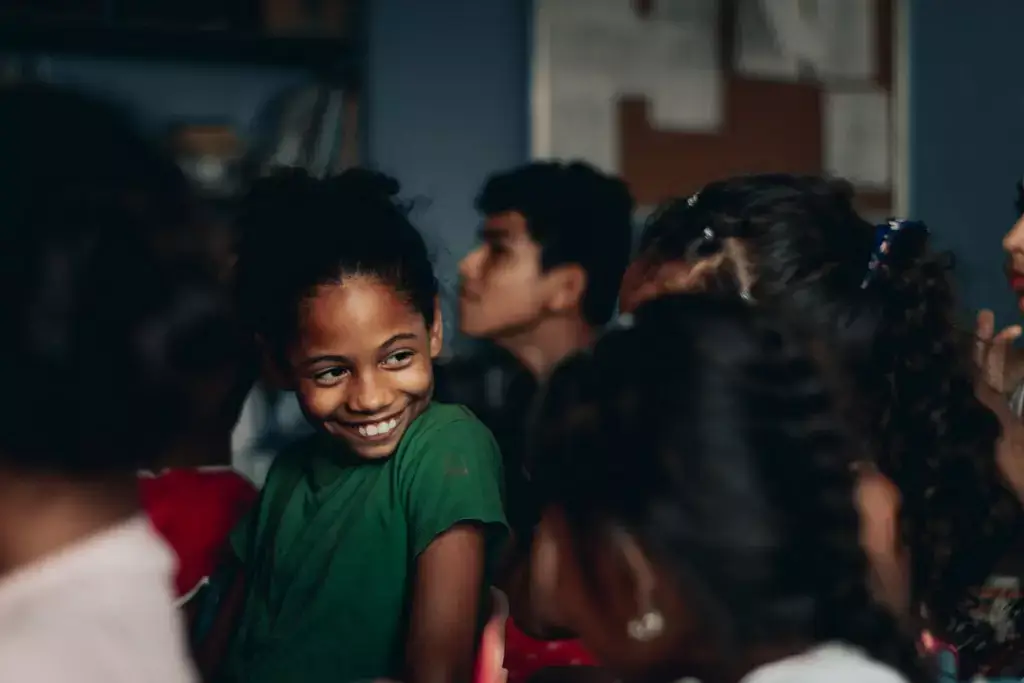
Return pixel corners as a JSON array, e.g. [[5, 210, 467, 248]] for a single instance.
[[535, 294, 925, 681]]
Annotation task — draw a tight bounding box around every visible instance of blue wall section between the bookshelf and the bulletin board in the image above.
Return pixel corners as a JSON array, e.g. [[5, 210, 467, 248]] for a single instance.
[[367, 0, 529, 348]]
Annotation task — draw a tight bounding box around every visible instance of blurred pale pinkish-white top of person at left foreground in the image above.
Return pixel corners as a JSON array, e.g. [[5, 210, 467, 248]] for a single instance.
[[0, 516, 198, 683]]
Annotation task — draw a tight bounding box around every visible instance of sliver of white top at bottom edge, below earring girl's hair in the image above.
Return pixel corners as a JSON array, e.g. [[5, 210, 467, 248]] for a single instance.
[[740, 644, 907, 683]]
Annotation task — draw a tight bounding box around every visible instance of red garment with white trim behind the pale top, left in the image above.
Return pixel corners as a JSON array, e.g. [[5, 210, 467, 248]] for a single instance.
[[138, 469, 258, 597]]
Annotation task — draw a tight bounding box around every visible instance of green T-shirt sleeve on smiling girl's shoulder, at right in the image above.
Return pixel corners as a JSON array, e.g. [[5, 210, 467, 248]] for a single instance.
[[399, 412, 507, 557]]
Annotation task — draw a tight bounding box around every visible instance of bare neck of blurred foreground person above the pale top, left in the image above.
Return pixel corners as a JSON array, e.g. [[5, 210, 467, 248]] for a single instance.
[[0, 471, 139, 577]]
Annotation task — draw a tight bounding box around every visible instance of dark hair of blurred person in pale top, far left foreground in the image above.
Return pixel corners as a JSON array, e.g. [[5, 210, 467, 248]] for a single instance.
[[0, 85, 234, 474]]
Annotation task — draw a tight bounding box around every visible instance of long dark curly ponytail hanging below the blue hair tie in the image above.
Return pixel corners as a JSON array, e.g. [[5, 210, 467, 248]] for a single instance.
[[861, 231, 1020, 621]]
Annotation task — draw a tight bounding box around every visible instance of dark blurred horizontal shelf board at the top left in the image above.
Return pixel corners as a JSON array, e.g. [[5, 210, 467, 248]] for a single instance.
[[0, 20, 360, 85]]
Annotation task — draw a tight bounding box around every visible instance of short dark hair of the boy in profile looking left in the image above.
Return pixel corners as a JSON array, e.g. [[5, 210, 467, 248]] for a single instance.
[[476, 162, 634, 326]]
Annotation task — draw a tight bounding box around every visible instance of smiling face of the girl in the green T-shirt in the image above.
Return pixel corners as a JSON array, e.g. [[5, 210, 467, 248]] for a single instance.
[[288, 275, 441, 460]]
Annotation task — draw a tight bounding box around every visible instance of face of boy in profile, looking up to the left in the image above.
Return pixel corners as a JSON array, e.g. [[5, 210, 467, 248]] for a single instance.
[[459, 211, 554, 341]]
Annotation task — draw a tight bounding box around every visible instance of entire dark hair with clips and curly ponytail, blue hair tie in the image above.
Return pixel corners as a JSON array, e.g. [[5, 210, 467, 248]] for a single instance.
[[639, 175, 1020, 623]]
